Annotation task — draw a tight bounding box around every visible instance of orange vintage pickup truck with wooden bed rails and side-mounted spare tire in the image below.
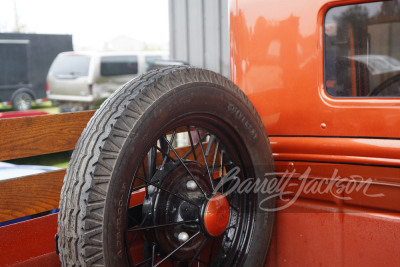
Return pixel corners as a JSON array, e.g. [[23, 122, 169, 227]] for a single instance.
[[0, 0, 400, 266]]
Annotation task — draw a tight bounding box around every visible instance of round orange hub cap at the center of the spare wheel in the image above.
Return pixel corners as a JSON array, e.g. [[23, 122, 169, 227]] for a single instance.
[[204, 195, 230, 236]]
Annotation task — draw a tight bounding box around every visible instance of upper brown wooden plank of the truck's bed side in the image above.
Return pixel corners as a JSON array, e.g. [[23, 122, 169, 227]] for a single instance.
[[0, 111, 94, 161]]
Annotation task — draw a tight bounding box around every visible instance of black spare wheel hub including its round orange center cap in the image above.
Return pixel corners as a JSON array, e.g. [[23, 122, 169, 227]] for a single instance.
[[142, 160, 230, 260]]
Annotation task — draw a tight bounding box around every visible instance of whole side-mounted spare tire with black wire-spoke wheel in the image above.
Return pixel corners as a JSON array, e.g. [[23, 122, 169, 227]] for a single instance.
[[58, 67, 275, 266]]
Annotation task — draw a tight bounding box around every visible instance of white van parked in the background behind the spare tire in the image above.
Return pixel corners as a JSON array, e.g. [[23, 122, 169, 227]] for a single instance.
[[47, 51, 167, 112]]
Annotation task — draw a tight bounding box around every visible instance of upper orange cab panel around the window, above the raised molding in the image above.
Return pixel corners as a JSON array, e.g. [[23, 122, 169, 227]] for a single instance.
[[230, 0, 400, 138]]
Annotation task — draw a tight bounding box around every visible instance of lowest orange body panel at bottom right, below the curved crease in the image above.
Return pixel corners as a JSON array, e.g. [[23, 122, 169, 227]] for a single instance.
[[266, 200, 400, 267]]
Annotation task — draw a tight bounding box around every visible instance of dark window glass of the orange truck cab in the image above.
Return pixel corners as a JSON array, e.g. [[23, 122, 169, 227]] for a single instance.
[[324, 0, 400, 97]]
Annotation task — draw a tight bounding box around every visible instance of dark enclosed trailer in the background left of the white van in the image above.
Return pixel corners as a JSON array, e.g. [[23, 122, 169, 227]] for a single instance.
[[0, 33, 73, 110]]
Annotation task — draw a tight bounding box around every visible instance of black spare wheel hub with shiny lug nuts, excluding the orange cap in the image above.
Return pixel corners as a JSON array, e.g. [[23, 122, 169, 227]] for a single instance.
[[143, 163, 210, 260]]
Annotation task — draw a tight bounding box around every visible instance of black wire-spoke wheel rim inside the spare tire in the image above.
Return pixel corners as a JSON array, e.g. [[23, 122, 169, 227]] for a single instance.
[[125, 114, 256, 266]]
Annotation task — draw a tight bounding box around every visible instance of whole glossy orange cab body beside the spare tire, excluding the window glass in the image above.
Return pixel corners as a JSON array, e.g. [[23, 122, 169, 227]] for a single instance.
[[230, 0, 400, 266]]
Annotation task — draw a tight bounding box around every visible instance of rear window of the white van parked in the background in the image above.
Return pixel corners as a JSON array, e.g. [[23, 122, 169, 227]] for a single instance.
[[49, 54, 90, 78]]
